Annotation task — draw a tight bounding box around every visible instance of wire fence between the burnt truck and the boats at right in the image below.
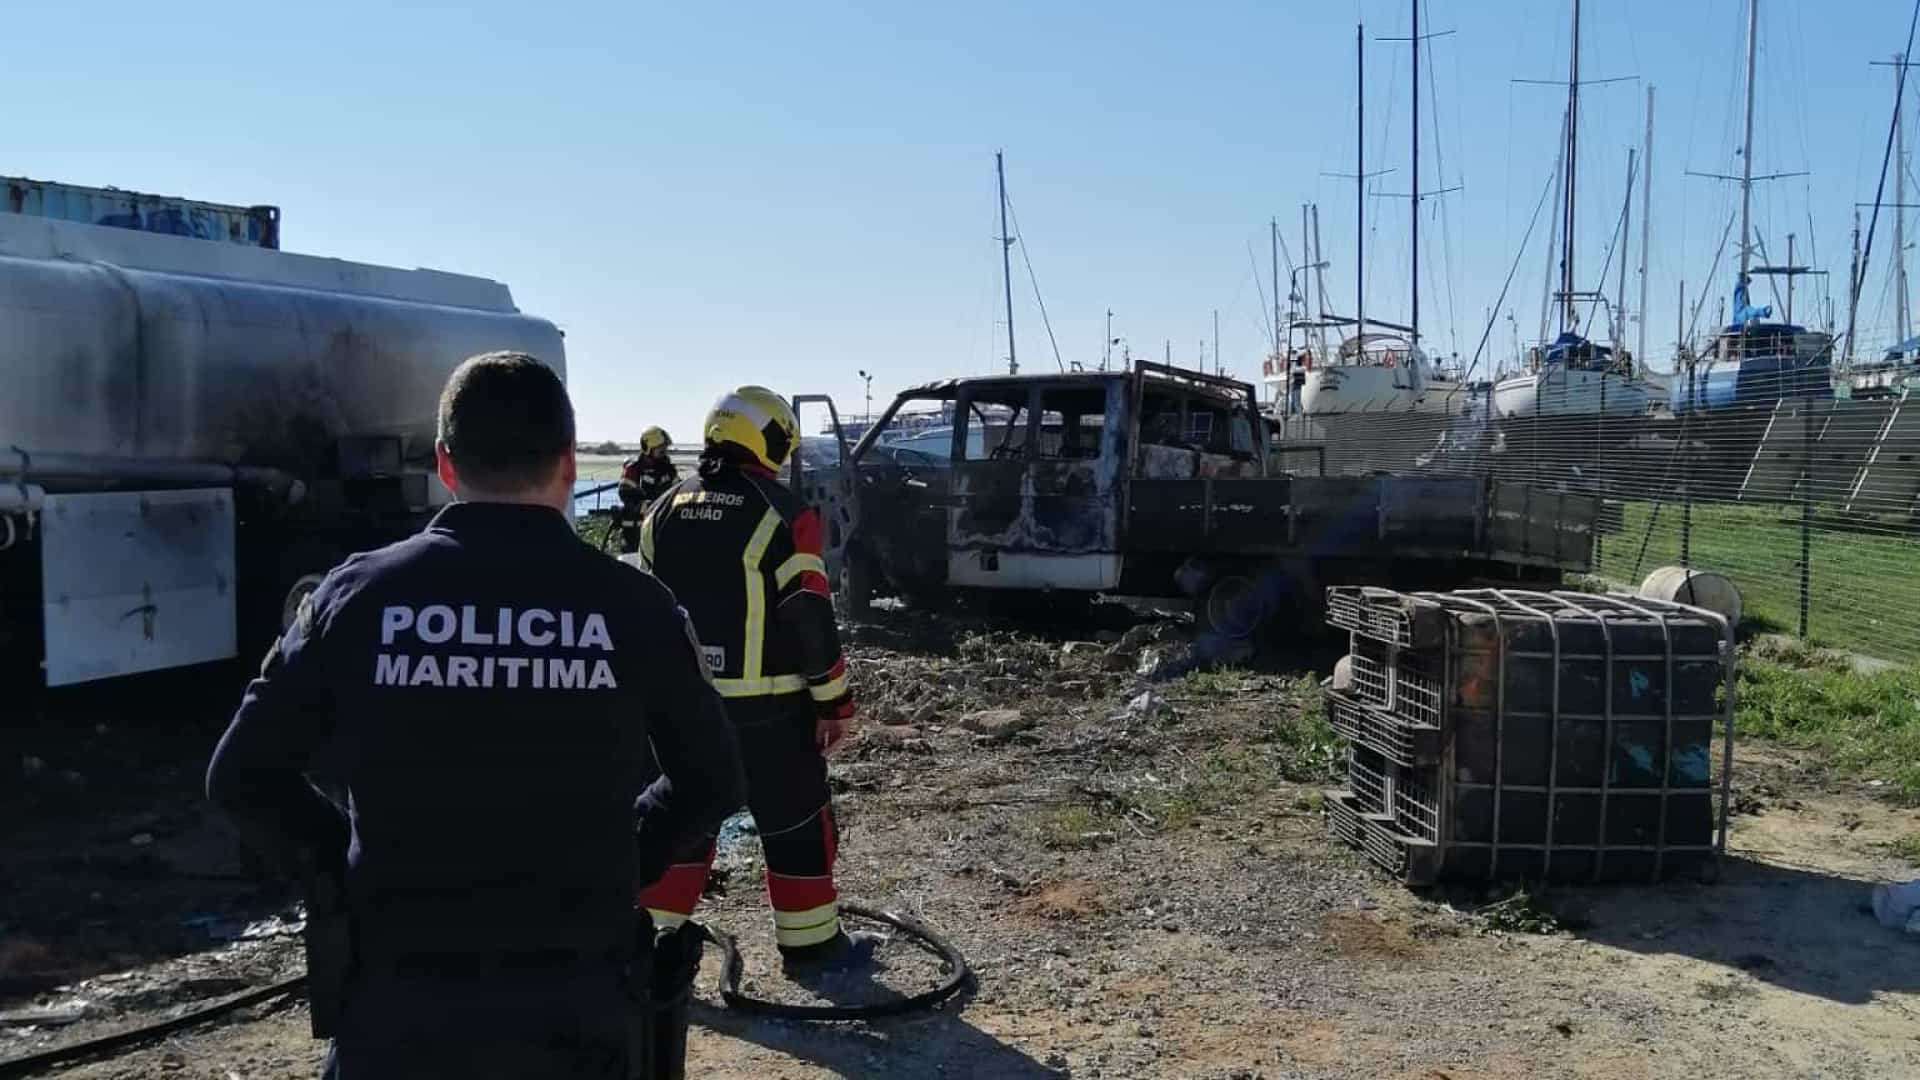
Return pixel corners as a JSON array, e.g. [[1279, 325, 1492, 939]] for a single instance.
[[1279, 379, 1920, 661]]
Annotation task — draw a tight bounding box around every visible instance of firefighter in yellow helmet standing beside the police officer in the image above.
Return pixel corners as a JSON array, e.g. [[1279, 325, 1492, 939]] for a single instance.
[[637, 386, 883, 978]]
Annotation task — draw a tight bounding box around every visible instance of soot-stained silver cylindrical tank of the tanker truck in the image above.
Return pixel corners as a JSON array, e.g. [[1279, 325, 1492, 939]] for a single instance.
[[0, 215, 564, 473]]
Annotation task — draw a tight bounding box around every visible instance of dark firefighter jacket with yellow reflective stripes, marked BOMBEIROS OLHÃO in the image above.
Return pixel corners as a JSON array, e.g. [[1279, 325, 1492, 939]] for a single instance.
[[639, 465, 852, 717]]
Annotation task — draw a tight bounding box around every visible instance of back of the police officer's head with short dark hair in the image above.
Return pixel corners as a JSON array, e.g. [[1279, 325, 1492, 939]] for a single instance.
[[440, 352, 574, 494]]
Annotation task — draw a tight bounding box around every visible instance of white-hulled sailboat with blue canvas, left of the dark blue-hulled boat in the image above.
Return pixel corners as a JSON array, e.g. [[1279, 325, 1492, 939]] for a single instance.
[[1494, 0, 1653, 419]]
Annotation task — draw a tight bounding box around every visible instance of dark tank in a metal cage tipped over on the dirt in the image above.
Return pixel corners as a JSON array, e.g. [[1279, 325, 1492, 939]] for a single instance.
[[1327, 588, 1734, 882]]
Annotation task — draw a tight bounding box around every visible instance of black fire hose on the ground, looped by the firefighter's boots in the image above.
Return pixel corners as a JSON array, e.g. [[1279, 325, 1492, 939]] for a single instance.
[[0, 903, 973, 1080]]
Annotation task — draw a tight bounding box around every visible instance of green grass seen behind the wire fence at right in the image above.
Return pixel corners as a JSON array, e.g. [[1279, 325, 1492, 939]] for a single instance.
[[1594, 502, 1920, 661]]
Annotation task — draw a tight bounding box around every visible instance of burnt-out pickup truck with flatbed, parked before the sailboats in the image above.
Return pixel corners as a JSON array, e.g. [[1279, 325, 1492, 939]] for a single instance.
[[795, 363, 1597, 619]]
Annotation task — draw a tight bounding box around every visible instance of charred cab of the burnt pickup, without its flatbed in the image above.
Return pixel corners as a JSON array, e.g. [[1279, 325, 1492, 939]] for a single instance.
[[845, 363, 1267, 596]]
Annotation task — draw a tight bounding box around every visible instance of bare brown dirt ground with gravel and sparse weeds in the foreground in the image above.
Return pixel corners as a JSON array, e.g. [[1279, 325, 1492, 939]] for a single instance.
[[0, 599, 1920, 1080]]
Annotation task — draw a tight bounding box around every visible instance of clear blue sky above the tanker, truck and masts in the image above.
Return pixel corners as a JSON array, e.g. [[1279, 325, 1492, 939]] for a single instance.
[[0, 0, 1920, 440]]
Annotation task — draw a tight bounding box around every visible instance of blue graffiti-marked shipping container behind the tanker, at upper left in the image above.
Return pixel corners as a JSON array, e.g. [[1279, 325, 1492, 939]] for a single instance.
[[0, 177, 280, 248]]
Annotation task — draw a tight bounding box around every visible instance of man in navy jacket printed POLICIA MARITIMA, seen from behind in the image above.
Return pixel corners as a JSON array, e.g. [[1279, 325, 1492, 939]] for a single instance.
[[207, 354, 745, 1080]]
